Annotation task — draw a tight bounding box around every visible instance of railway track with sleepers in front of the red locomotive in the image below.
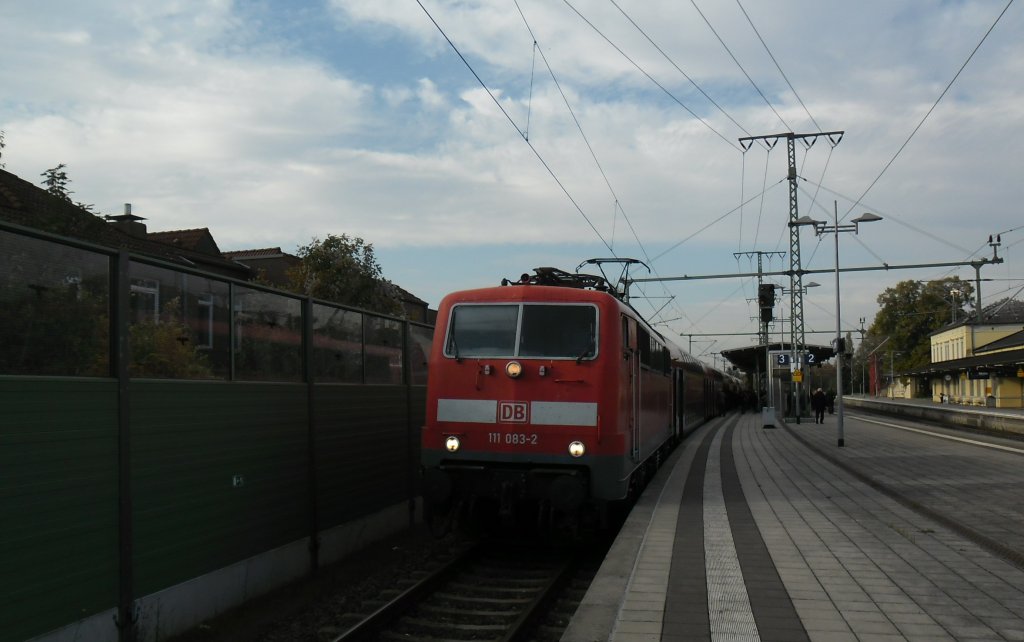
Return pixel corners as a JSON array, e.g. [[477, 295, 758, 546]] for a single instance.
[[332, 543, 583, 642]]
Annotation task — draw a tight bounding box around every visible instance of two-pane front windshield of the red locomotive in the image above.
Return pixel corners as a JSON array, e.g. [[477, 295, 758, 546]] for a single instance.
[[444, 303, 597, 359]]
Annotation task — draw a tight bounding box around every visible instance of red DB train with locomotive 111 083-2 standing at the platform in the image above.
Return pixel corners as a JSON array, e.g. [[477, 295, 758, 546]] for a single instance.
[[422, 267, 727, 527]]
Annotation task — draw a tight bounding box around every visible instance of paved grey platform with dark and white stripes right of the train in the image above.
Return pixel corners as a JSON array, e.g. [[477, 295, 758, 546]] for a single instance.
[[562, 412, 1024, 642]]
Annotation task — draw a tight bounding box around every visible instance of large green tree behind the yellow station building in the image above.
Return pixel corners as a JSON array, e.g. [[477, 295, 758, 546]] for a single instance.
[[858, 276, 974, 371]]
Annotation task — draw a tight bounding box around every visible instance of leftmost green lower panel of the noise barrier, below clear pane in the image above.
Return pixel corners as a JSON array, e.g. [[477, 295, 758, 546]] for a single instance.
[[0, 378, 118, 642]]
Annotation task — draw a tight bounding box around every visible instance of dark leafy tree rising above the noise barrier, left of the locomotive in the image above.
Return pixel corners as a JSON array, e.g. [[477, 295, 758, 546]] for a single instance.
[[288, 234, 403, 316]]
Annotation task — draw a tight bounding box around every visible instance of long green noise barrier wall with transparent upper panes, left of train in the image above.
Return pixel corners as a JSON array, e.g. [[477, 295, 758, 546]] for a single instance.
[[0, 221, 432, 642]]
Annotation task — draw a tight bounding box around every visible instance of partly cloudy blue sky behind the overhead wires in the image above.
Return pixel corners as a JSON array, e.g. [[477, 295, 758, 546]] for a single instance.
[[0, 0, 1024, 365]]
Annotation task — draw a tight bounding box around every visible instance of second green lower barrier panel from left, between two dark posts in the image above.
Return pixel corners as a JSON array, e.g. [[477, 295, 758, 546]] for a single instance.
[[131, 381, 308, 595]]
